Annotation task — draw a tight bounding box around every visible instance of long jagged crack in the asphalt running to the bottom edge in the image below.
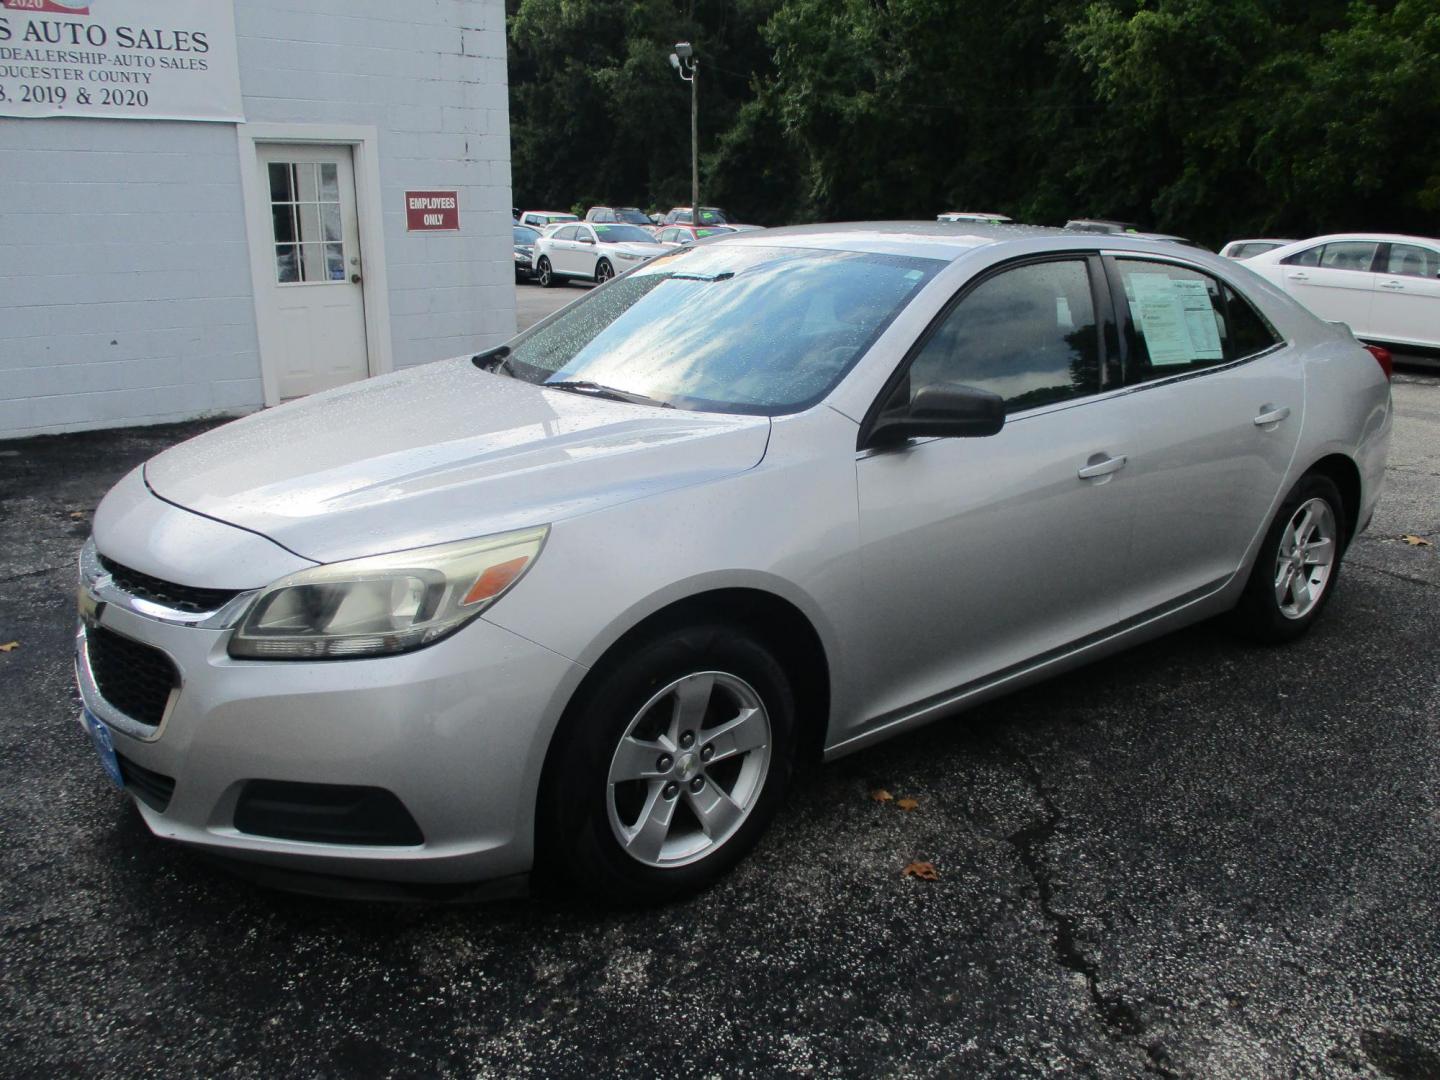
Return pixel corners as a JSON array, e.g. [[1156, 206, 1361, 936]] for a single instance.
[[988, 732, 1184, 1079]]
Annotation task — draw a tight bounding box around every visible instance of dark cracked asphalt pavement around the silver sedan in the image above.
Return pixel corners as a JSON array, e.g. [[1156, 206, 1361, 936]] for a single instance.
[[0, 361, 1440, 1080]]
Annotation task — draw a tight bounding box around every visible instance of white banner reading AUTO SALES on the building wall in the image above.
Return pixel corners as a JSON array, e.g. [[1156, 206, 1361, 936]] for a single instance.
[[0, 0, 245, 121]]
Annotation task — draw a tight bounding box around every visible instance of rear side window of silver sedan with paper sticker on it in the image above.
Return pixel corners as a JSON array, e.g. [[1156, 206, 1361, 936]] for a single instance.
[[1115, 259, 1255, 384]]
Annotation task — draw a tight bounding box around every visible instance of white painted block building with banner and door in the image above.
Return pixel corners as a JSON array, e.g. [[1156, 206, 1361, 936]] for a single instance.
[[0, 0, 516, 438]]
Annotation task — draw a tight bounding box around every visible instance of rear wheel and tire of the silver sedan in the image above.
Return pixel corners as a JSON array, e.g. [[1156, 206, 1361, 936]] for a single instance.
[[1231, 472, 1349, 644]]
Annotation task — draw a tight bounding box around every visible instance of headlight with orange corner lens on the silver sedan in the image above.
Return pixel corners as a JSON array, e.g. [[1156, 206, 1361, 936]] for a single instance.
[[230, 526, 550, 660]]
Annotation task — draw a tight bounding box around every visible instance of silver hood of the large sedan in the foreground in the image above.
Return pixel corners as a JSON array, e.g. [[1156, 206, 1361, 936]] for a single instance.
[[145, 364, 770, 563]]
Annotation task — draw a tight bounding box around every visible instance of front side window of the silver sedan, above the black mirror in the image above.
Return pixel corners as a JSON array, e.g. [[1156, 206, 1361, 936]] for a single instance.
[[909, 259, 1100, 413]]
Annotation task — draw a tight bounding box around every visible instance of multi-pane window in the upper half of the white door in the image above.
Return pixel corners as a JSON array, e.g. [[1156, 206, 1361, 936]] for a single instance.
[[266, 161, 346, 285]]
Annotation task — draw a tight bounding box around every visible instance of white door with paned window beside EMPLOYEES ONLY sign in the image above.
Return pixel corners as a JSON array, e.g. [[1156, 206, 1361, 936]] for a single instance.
[[258, 144, 370, 400]]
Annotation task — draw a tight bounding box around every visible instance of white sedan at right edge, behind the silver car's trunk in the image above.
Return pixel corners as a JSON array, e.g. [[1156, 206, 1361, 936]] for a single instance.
[[1246, 232, 1440, 348]]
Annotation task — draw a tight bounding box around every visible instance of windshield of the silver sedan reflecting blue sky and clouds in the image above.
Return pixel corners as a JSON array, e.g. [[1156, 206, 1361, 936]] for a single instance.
[[505, 243, 943, 416]]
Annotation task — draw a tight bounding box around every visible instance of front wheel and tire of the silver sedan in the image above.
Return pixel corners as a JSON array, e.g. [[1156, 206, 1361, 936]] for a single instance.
[[537, 624, 796, 904]]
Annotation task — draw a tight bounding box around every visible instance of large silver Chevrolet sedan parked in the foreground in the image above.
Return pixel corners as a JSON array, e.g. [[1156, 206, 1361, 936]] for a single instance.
[[76, 223, 1391, 901]]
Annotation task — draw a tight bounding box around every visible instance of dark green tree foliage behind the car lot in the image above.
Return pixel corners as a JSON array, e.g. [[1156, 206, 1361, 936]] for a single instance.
[[508, 0, 1440, 243]]
